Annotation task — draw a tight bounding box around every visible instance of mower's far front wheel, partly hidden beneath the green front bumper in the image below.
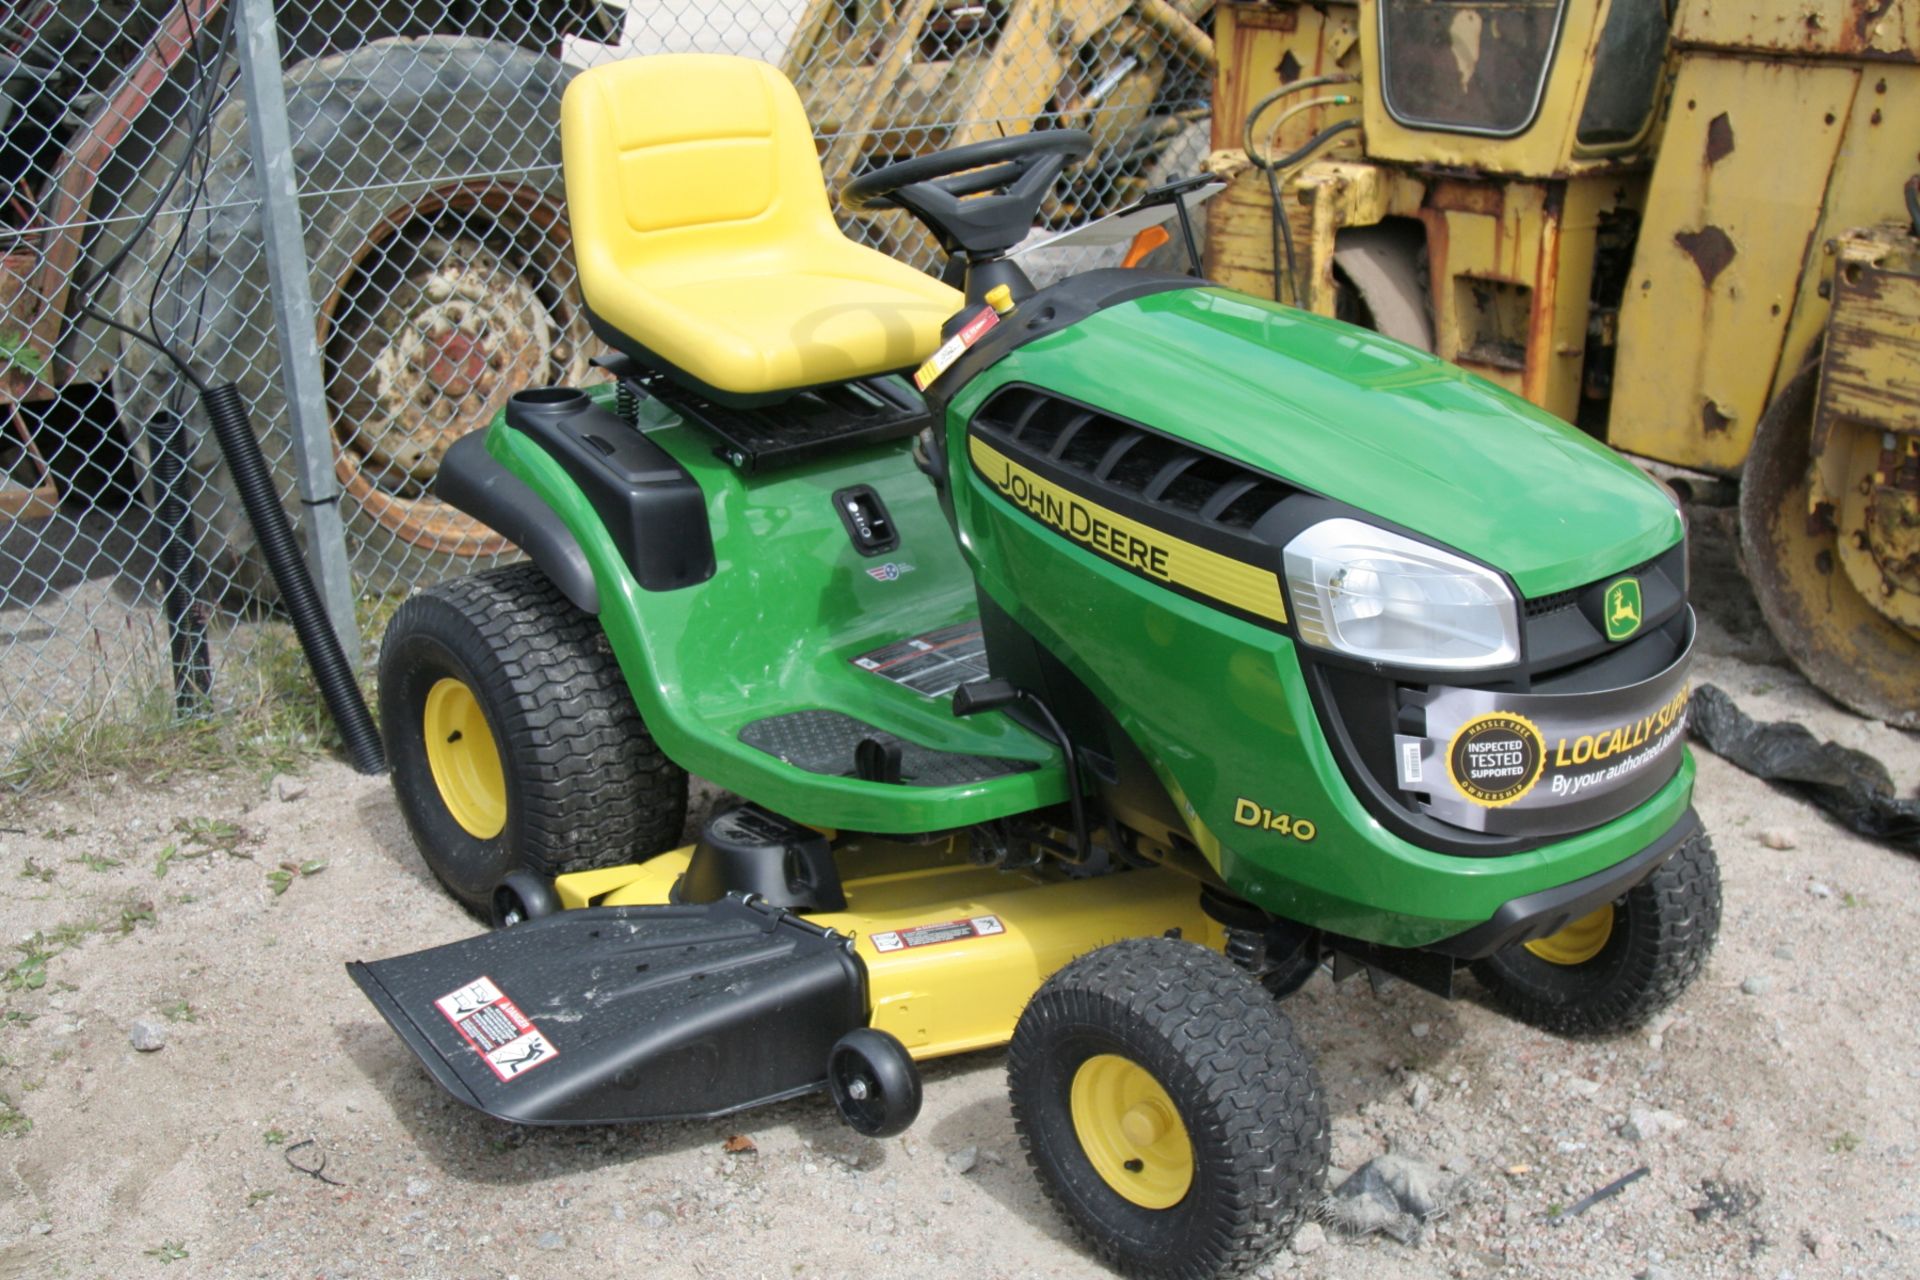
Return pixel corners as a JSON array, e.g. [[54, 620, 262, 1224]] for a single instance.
[[1473, 833, 1720, 1036]]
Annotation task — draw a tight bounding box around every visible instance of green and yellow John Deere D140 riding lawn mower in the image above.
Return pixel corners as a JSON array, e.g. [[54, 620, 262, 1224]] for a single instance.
[[351, 56, 1720, 1276]]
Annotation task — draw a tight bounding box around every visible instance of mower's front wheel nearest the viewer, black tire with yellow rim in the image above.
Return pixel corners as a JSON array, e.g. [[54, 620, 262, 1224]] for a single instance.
[[1006, 938, 1329, 1278]]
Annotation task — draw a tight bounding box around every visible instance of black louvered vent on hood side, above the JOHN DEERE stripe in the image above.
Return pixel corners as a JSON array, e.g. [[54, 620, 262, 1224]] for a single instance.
[[973, 386, 1290, 532]]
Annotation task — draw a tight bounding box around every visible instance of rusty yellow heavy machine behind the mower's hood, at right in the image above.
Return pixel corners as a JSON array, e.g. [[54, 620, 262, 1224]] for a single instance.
[[1208, 0, 1920, 727]]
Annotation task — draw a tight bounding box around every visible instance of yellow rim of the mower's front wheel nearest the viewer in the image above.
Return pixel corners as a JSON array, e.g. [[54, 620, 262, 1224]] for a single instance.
[[1068, 1054, 1194, 1209]]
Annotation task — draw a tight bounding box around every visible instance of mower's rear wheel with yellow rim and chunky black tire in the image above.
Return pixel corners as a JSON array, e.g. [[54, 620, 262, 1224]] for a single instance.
[[380, 564, 687, 913]]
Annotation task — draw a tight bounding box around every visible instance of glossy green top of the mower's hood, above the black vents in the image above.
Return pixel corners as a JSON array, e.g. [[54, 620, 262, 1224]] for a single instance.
[[952, 288, 1682, 597]]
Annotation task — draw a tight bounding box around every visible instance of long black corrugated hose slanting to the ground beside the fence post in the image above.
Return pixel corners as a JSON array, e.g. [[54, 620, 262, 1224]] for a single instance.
[[200, 382, 386, 773]]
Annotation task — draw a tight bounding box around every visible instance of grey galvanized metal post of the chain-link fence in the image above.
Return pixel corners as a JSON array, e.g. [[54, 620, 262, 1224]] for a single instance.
[[234, 0, 361, 670]]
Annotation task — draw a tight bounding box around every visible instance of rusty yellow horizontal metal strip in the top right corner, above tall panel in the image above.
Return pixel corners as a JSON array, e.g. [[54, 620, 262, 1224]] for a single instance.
[[1674, 0, 1920, 63]]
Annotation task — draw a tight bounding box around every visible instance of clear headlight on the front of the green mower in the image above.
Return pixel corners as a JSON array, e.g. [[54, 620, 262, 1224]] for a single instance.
[[1284, 520, 1521, 672]]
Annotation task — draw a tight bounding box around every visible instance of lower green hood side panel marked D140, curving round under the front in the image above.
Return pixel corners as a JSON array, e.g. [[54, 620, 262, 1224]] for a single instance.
[[950, 449, 1693, 946]]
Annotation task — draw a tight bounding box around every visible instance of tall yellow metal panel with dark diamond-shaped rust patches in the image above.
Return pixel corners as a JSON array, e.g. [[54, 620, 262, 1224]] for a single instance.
[[1607, 54, 1859, 472]]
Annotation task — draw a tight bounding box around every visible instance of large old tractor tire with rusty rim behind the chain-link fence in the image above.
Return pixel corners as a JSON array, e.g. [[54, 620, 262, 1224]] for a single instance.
[[113, 36, 591, 597]]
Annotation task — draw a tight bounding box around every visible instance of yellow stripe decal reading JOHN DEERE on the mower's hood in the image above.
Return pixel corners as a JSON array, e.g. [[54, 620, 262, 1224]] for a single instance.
[[968, 436, 1286, 622]]
